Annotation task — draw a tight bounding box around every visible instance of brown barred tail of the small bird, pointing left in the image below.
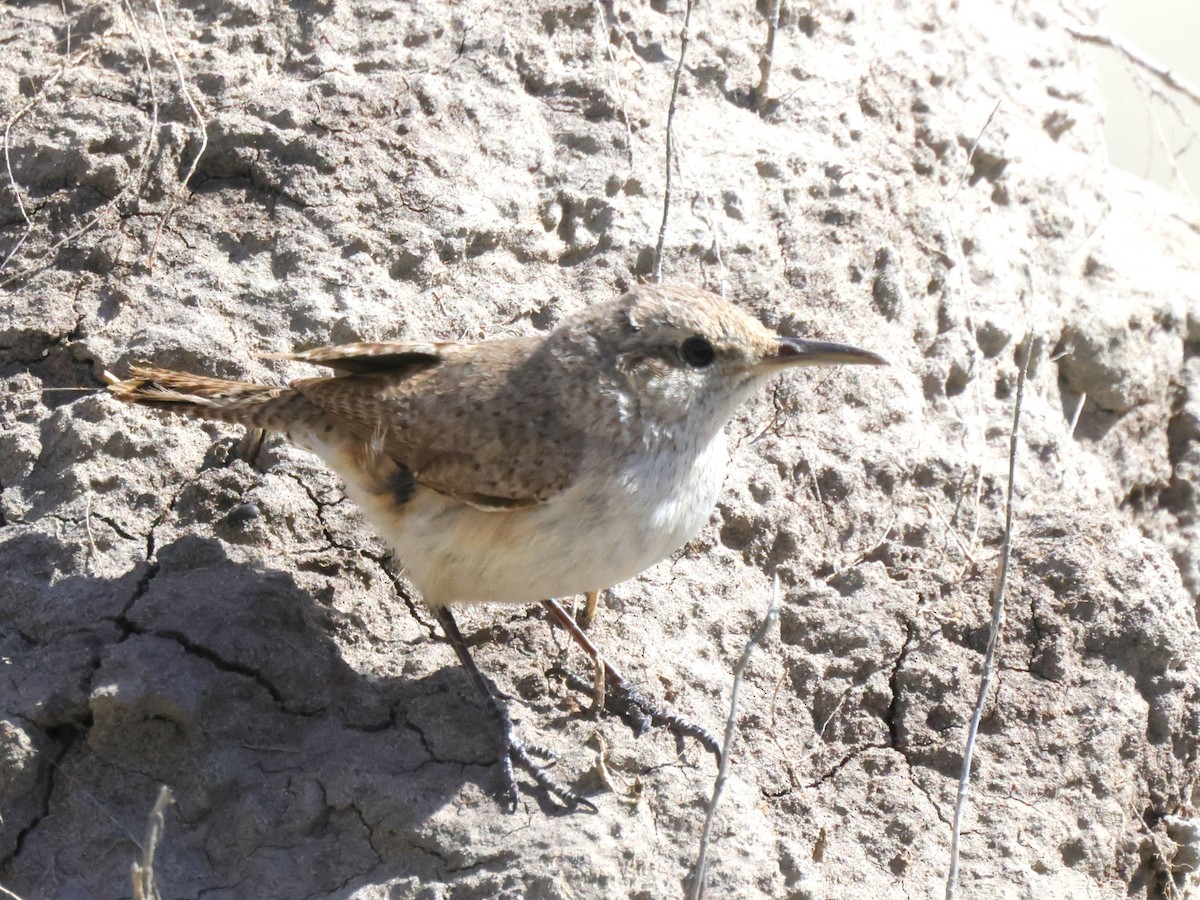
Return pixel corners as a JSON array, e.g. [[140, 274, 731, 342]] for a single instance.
[[104, 366, 324, 432]]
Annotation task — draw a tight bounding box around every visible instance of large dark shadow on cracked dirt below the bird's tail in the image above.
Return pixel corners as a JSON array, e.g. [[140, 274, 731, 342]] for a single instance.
[[0, 526, 595, 898]]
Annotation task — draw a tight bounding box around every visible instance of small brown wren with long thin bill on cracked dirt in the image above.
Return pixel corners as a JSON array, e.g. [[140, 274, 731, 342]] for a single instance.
[[107, 286, 886, 810]]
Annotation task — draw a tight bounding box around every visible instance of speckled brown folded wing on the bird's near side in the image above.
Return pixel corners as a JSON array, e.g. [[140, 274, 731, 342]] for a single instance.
[[290, 338, 583, 510]]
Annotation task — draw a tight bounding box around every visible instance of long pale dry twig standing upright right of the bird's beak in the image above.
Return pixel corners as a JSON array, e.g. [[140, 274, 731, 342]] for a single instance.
[[946, 331, 1033, 900]]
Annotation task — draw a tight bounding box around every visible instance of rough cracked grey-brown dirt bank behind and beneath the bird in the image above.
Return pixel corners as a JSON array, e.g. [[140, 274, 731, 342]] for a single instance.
[[0, 0, 1200, 900]]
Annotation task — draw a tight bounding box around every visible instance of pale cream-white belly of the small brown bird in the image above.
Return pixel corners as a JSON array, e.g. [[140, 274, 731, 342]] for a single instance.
[[305, 432, 726, 606]]
